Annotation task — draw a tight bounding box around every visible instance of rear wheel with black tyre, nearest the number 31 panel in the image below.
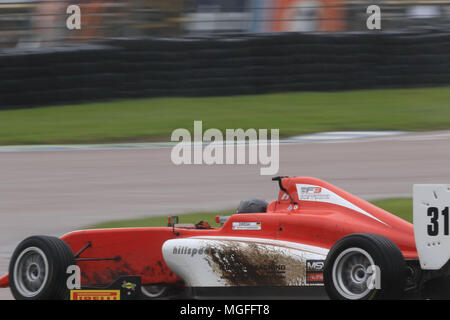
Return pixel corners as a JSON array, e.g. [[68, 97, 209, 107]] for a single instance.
[[323, 233, 406, 300]]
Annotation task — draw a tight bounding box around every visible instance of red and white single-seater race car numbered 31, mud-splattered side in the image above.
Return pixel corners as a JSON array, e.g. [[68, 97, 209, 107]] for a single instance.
[[0, 177, 450, 300]]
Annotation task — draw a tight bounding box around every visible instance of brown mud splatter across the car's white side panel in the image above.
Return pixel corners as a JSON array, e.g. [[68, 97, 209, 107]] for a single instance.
[[205, 242, 306, 286]]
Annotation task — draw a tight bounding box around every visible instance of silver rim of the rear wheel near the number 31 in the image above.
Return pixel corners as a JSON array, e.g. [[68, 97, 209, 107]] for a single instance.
[[332, 248, 375, 300]]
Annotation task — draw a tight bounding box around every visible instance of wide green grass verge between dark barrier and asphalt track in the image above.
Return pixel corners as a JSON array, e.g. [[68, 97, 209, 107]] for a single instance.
[[0, 87, 450, 145]]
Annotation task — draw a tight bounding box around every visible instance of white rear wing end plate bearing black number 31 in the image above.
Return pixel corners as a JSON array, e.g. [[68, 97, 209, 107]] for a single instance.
[[413, 184, 450, 270]]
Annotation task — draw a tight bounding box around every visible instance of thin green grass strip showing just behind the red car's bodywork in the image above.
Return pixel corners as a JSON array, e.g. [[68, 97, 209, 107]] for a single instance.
[[88, 198, 412, 229]]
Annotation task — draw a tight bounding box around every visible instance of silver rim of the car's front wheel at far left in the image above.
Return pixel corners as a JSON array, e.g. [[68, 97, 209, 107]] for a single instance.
[[14, 247, 48, 298]]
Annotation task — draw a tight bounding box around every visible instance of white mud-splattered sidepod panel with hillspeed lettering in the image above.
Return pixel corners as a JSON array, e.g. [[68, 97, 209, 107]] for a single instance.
[[162, 237, 328, 287]]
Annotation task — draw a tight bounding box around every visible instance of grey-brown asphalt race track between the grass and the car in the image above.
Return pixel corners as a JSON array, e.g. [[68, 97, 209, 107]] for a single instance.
[[0, 131, 450, 299]]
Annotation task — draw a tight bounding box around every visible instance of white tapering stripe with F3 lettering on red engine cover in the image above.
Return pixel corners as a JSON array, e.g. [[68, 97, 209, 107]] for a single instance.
[[296, 184, 386, 224]]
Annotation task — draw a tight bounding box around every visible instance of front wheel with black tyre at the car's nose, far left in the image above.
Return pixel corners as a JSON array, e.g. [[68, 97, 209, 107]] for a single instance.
[[9, 236, 75, 300]]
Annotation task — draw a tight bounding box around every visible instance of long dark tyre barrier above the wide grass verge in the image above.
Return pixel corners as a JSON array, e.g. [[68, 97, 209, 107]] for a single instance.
[[0, 29, 450, 109]]
